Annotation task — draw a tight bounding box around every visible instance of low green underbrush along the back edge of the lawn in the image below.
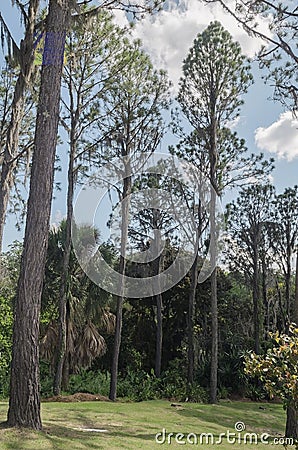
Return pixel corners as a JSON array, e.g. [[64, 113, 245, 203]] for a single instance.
[[0, 360, 267, 403]]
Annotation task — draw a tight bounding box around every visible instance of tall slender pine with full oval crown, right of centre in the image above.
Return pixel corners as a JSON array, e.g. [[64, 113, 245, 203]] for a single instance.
[[178, 22, 252, 403]]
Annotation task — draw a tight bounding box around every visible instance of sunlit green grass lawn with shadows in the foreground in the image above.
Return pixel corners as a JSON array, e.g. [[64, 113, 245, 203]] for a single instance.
[[0, 401, 294, 450]]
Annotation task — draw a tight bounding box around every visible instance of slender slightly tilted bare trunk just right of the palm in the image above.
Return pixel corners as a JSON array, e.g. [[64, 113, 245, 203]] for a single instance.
[[109, 167, 131, 401]]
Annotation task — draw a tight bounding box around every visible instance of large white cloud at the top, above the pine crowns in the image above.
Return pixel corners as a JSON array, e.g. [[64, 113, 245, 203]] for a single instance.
[[117, 0, 274, 89]]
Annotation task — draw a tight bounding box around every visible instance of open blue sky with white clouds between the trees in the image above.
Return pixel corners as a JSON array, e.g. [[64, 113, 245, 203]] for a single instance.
[[0, 0, 298, 248]]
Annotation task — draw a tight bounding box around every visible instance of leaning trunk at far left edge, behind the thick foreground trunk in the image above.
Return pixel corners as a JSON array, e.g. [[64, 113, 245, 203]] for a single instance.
[[0, 0, 40, 253]]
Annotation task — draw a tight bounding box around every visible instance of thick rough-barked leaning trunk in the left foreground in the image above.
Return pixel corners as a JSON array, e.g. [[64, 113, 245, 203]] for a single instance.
[[8, 0, 70, 430]]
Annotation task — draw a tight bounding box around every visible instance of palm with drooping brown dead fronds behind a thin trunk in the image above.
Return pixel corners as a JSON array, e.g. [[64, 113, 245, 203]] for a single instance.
[[40, 220, 115, 389]]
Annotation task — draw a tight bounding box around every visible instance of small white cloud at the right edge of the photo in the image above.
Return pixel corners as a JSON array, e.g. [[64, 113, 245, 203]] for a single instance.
[[255, 111, 298, 161]]
